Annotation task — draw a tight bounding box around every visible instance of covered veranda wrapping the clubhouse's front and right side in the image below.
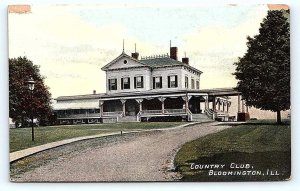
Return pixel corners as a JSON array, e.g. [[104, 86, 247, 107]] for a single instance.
[[99, 90, 237, 122]]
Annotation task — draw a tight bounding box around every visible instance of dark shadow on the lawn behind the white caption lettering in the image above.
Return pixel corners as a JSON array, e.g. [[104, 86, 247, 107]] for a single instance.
[[179, 151, 291, 182]]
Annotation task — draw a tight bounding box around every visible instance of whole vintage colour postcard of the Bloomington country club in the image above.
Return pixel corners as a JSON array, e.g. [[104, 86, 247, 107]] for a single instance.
[[8, 4, 292, 182]]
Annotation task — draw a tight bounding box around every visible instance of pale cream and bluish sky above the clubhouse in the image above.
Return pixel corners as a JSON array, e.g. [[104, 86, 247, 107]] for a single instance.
[[9, 4, 268, 98]]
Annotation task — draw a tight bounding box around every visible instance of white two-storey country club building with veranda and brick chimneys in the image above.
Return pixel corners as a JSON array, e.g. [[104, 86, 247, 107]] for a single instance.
[[54, 47, 248, 124]]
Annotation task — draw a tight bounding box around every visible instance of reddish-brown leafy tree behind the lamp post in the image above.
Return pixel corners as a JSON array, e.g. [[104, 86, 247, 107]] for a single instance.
[[9, 57, 52, 127]]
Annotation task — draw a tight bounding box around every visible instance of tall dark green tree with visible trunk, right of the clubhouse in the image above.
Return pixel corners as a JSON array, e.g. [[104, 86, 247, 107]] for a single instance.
[[234, 10, 290, 123]]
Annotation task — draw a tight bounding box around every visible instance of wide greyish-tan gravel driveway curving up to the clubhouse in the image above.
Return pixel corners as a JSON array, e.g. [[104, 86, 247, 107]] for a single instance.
[[11, 122, 229, 182]]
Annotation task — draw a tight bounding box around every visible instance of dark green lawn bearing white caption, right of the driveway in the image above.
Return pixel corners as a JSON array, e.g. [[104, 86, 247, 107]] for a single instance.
[[175, 121, 291, 181]]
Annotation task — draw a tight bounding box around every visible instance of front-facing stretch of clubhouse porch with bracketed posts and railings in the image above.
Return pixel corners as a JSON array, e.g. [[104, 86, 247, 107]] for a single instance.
[[99, 93, 223, 123]]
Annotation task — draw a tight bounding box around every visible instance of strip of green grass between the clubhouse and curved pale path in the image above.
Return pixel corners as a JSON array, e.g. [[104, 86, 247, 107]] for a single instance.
[[9, 122, 184, 152]]
